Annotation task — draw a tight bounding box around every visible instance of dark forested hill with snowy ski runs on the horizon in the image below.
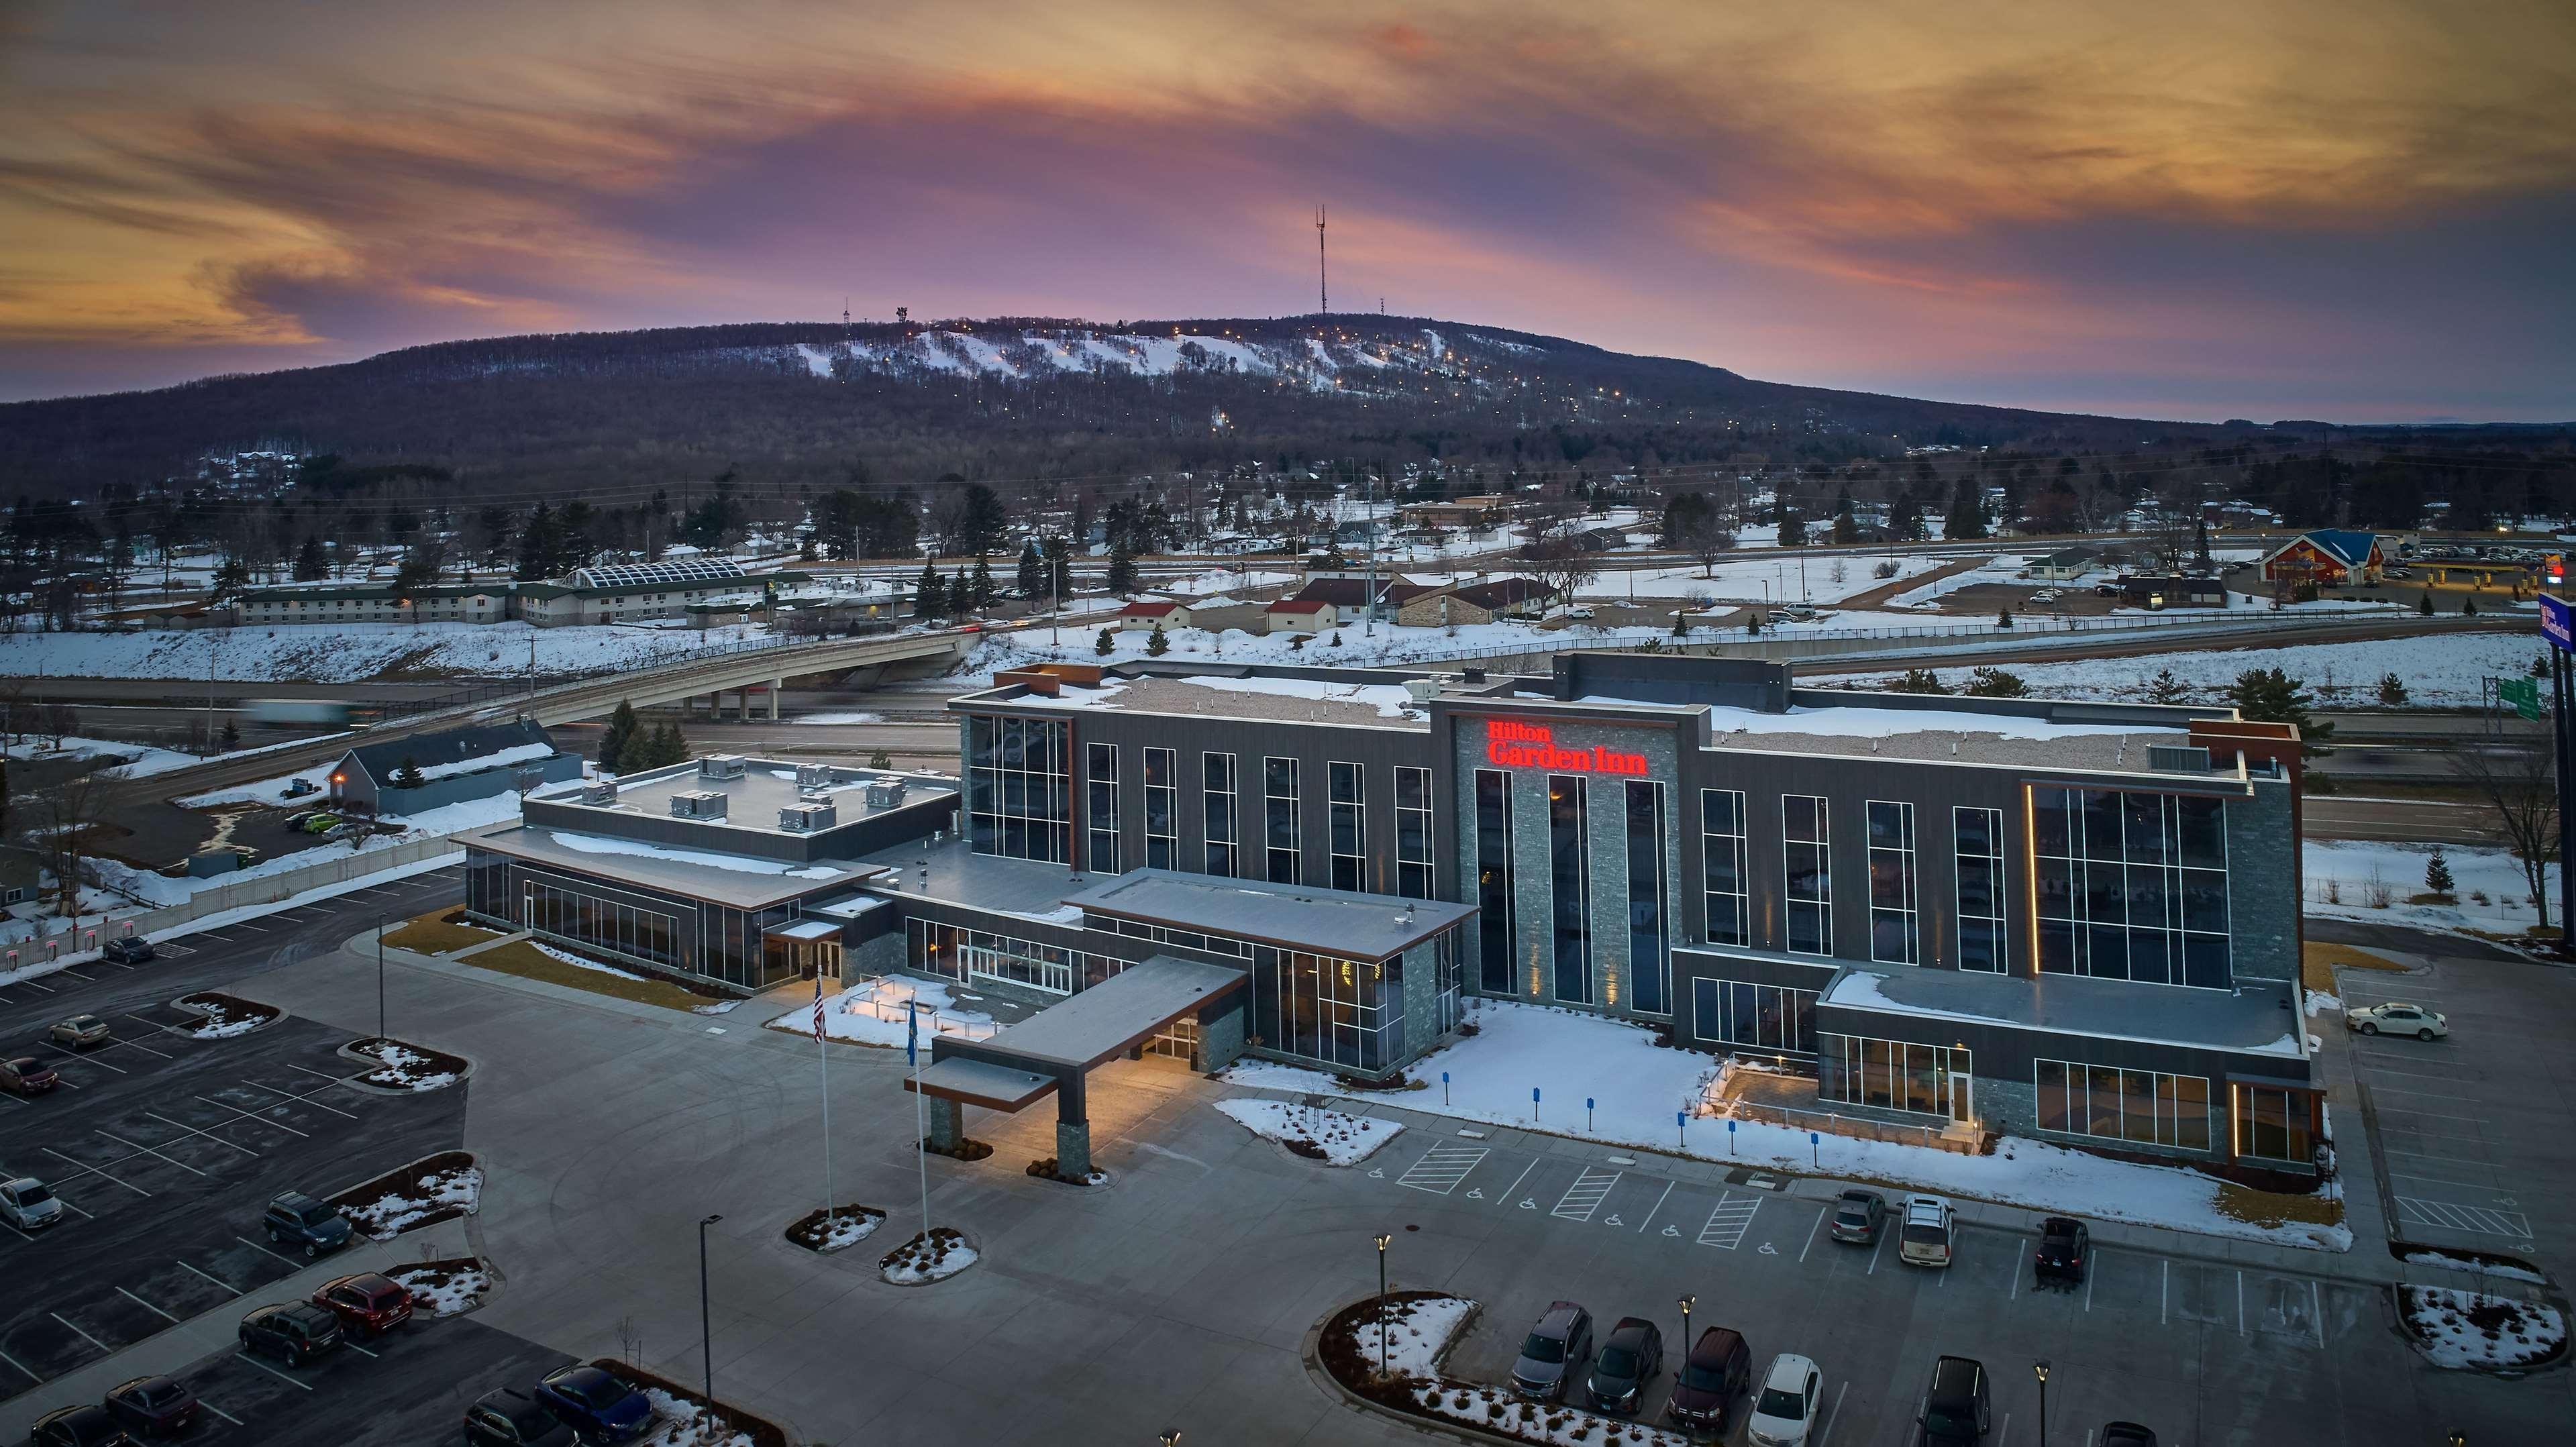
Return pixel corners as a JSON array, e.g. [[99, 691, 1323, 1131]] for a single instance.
[[0, 317, 2318, 500]]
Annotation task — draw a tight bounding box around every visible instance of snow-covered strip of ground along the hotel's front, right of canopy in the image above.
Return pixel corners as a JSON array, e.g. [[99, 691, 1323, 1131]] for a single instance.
[[1226, 1002, 2352, 1251]]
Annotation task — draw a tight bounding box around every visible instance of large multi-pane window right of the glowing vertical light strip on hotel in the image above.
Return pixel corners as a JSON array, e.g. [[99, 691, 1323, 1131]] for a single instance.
[[2030, 786, 2231, 989]]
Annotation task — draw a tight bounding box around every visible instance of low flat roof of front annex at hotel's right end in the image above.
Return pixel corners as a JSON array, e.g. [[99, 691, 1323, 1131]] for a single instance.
[[1816, 965, 2308, 1061]]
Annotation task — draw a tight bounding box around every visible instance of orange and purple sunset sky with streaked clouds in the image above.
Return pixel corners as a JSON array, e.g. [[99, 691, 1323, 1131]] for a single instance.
[[0, 0, 2576, 420]]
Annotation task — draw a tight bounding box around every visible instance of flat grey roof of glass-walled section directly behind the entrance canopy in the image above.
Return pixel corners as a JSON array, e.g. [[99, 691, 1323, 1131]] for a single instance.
[[1066, 870, 1476, 961]]
